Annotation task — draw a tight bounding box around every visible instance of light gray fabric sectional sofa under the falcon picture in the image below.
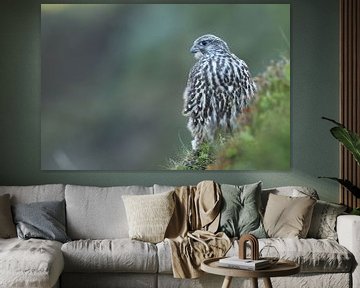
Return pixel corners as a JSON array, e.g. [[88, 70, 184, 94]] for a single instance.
[[0, 184, 360, 288]]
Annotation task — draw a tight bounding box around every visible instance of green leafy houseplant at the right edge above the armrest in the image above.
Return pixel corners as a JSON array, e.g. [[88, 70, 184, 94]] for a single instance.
[[319, 117, 360, 215]]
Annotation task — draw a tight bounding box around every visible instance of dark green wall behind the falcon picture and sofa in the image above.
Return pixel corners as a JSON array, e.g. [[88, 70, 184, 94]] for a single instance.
[[0, 0, 339, 201]]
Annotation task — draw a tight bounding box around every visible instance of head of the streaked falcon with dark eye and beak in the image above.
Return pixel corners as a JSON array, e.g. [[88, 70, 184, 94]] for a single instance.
[[190, 34, 230, 59]]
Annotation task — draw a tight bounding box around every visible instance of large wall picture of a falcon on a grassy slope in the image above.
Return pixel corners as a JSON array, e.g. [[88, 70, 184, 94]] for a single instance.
[[41, 4, 291, 171]]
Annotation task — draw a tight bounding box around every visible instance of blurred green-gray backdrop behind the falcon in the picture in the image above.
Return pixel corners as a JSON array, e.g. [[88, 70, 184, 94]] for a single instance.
[[41, 4, 290, 170]]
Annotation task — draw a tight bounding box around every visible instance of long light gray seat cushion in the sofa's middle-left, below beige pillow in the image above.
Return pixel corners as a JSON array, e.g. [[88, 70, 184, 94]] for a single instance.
[[61, 239, 158, 273]]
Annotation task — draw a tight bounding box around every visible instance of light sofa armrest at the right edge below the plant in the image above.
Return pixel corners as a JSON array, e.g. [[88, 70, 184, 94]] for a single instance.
[[336, 215, 360, 287]]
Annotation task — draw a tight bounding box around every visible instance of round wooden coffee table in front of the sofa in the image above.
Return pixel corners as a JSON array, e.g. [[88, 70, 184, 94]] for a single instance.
[[201, 258, 300, 288]]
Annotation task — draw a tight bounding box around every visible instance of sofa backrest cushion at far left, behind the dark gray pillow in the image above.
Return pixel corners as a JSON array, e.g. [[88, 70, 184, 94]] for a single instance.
[[0, 184, 65, 205]]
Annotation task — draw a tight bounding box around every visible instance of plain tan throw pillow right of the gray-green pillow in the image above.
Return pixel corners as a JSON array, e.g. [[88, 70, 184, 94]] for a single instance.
[[264, 194, 316, 238]]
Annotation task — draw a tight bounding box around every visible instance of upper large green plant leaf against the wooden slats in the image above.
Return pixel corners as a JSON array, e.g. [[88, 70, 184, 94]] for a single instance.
[[323, 117, 360, 165]]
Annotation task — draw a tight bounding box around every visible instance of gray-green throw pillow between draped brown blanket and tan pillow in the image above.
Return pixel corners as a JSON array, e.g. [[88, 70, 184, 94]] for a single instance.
[[219, 182, 266, 238]]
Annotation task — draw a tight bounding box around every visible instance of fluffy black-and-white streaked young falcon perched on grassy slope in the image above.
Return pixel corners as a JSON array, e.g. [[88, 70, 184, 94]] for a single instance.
[[183, 34, 256, 150]]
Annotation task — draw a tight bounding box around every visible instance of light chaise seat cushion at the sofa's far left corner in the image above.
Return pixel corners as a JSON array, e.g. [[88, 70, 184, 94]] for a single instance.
[[0, 238, 64, 288]]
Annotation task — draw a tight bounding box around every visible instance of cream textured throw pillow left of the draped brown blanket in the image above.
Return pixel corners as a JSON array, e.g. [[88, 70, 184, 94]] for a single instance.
[[122, 191, 175, 243]]
